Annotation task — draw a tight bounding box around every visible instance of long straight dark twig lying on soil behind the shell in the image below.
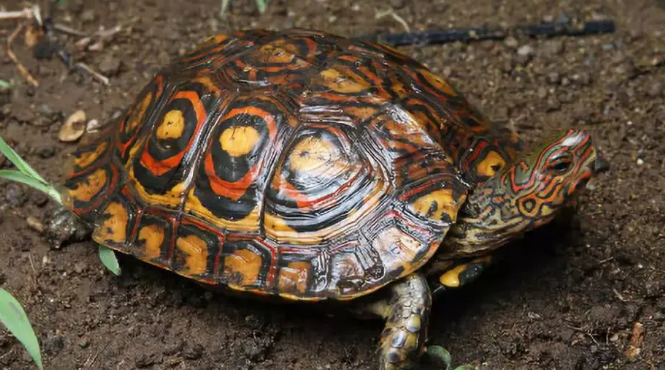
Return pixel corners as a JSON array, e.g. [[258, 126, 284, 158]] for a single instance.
[[362, 20, 616, 46]]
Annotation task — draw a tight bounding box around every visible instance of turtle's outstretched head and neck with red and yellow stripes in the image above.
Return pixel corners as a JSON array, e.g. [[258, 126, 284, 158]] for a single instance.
[[446, 129, 599, 256]]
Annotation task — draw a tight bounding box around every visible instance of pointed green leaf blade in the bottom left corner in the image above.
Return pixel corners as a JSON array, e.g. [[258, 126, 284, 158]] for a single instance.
[[0, 288, 44, 369]]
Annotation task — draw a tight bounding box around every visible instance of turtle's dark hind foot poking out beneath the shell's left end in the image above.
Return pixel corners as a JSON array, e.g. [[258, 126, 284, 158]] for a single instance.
[[44, 207, 92, 248]]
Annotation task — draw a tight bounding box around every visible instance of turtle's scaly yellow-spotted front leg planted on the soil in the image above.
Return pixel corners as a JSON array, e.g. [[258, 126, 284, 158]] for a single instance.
[[357, 274, 432, 370]]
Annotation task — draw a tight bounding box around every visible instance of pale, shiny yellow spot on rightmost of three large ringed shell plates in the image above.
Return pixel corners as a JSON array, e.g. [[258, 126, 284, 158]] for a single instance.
[[289, 137, 349, 177]]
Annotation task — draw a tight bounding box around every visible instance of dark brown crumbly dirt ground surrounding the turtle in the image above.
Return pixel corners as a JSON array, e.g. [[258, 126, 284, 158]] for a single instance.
[[0, 0, 665, 370]]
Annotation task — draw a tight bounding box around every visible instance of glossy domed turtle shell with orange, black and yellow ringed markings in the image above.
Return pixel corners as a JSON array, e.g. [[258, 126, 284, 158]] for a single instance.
[[59, 29, 519, 300]]
